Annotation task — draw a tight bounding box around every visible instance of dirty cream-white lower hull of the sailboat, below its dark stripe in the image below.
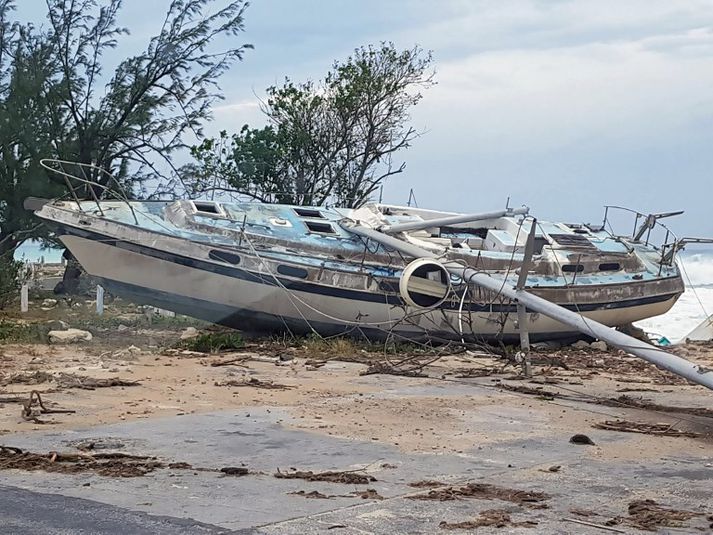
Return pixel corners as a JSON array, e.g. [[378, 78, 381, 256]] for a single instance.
[[61, 234, 678, 340]]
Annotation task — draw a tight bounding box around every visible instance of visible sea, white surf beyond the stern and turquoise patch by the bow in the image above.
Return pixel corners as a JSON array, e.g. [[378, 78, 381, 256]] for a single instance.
[[15, 242, 713, 343]]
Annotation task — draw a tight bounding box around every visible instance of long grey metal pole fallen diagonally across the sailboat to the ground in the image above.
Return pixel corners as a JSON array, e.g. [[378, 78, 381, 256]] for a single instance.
[[340, 222, 713, 390]]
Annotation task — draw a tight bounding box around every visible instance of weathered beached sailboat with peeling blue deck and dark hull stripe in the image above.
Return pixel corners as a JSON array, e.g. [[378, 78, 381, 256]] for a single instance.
[[29, 161, 684, 340]]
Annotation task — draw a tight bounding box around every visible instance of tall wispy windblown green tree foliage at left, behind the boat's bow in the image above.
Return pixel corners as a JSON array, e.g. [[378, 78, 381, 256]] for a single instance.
[[0, 0, 250, 266]]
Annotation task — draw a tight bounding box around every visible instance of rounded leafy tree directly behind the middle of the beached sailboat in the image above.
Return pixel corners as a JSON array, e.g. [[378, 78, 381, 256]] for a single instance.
[[183, 43, 434, 207]]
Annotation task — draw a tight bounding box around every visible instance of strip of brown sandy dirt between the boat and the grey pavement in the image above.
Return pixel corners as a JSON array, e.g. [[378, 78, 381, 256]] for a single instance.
[[0, 303, 713, 459]]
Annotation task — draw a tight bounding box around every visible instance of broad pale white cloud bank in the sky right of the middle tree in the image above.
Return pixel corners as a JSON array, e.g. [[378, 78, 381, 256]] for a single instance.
[[414, 22, 713, 151]]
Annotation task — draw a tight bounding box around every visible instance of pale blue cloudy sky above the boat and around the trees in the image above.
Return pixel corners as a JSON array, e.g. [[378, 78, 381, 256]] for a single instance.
[[18, 0, 713, 237]]
